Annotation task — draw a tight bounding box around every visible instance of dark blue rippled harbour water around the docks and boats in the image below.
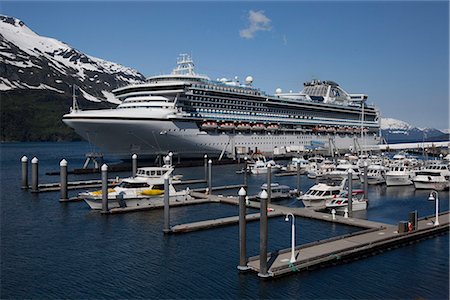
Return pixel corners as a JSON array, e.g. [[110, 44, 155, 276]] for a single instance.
[[0, 142, 449, 299]]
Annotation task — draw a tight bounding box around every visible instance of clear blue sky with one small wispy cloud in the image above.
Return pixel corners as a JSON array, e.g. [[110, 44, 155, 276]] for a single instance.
[[0, 1, 450, 129]]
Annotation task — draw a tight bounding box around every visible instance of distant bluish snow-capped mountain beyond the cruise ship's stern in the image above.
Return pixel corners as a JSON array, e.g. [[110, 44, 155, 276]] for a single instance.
[[381, 118, 448, 143]]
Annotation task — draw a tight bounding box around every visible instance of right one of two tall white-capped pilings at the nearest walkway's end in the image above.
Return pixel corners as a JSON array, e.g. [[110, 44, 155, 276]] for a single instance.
[[258, 190, 269, 278]]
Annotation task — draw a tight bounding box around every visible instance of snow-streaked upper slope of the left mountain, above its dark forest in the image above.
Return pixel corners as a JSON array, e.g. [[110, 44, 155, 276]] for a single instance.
[[0, 15, 145, 103]]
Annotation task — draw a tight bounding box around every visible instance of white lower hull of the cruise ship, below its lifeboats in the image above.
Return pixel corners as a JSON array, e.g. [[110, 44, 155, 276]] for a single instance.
[[64, 109, 378, 159]]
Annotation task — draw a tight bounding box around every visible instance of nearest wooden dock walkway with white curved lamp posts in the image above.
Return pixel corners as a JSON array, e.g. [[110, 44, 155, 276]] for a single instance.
[[247, 212, 449, 277]]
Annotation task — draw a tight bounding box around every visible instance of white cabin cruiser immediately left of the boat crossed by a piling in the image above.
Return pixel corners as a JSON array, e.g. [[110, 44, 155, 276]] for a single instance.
[[298, 177, 347, 207]]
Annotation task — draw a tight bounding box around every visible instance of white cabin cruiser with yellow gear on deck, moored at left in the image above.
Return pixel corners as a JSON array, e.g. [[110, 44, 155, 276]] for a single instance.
[[79, 165, 190, 209]]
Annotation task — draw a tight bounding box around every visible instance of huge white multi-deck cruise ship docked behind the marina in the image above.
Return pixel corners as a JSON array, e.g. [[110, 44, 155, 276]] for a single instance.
[[63, 54, 380, 159]]
